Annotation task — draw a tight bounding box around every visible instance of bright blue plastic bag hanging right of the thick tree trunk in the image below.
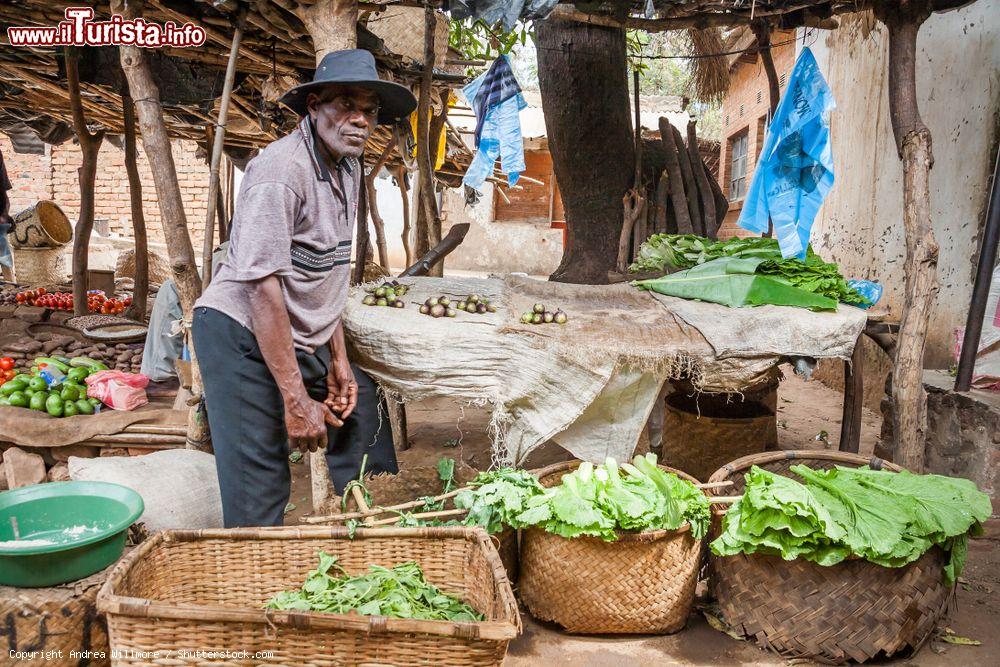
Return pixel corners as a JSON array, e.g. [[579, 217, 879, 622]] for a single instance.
[[737, 48, 835, 259]]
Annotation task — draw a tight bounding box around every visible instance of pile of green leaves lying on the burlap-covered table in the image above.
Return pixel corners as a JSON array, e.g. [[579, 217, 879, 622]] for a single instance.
[[629, 234, 868, 308]]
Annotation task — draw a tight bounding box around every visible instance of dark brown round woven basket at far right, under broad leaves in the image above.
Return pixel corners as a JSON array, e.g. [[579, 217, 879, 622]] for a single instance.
[[709, 451, 952, 663]]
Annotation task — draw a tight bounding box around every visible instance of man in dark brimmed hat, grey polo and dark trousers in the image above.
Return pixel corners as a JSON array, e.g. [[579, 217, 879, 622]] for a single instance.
[[192, 49, 417, 527]]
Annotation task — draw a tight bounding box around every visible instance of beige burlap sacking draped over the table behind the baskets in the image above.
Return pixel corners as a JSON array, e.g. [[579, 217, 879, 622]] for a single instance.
[[344, 276, 865, 463]]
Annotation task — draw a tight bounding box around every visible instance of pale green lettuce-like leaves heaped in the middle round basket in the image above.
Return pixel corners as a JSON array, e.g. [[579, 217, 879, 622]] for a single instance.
[[513, 454, 710, 541]]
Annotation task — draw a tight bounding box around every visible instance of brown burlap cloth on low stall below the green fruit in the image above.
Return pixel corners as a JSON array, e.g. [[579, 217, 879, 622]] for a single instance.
[[0, 405, 187, 447]]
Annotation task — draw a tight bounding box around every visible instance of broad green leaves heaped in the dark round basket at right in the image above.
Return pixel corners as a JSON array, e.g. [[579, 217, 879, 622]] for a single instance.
[[711, 465, 992, 585]]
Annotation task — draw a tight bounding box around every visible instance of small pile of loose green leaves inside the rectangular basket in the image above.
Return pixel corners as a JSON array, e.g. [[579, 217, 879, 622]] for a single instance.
[[266, 551, 483, 621]]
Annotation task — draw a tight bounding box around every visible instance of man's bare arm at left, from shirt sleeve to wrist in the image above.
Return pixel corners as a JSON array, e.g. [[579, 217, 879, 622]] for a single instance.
[[251, 276, 309, 406]]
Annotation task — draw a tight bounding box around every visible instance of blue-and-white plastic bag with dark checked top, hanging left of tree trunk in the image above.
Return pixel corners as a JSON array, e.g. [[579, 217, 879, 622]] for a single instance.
[[462, 55, 528, 192]]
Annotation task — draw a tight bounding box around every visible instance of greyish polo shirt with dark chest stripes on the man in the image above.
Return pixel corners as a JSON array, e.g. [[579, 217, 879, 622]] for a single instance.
[[195, 116, 361, 353]]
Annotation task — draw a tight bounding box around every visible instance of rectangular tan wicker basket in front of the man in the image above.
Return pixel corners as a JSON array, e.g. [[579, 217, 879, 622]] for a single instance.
[[98, 526, 520, 665]]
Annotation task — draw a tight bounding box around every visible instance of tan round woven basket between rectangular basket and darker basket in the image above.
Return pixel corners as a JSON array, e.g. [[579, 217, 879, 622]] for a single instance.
[[518, 461, 701, 634]]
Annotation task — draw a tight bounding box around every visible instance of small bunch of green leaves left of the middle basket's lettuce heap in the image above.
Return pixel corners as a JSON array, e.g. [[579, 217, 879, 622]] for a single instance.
[[455, 468, 545, 534]]
